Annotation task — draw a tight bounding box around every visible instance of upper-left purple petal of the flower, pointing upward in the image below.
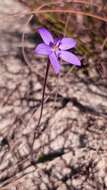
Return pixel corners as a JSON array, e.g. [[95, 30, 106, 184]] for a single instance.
[[38, 28, 54, 45]]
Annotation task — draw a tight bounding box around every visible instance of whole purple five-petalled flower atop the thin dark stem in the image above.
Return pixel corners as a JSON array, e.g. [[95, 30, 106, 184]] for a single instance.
[[34, 28, 81, 74]]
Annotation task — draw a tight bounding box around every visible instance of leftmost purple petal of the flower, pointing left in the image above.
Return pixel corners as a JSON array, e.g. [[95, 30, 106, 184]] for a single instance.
[[34, 43, 51, 55]]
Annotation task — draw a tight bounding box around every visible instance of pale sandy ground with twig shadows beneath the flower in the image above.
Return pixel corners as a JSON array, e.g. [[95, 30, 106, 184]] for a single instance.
[[0, 0, 107, 190]]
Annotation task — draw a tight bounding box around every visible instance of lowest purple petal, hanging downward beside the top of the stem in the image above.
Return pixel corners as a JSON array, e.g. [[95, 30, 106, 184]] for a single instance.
[[49, 53, 60, 74]]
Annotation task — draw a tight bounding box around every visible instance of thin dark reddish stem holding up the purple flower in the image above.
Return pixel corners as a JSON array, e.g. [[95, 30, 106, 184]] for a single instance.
[[31, 60, 50, 159]]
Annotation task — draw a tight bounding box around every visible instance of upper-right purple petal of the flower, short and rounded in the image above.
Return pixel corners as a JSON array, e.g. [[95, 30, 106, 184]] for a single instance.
[[59, 38, 76, 50]]
